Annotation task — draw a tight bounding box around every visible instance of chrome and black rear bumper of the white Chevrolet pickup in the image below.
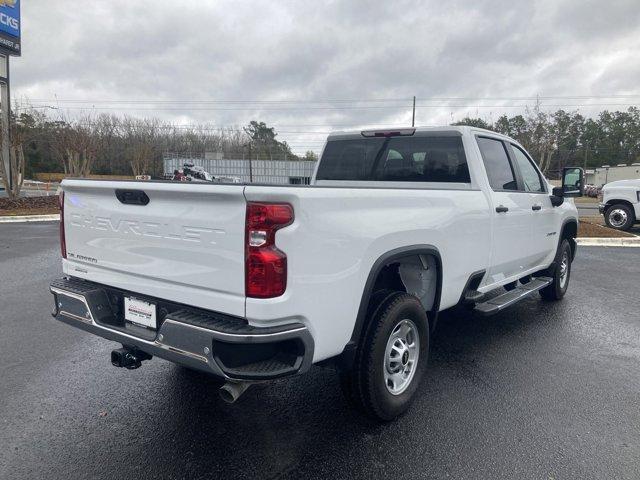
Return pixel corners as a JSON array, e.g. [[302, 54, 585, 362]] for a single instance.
[[50, 278, 314, 380]]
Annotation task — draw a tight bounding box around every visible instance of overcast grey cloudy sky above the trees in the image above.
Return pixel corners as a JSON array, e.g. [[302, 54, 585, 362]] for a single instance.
[[12, 0, 640, 151]]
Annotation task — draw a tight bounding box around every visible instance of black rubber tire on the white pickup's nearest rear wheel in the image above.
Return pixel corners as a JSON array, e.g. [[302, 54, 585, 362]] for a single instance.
[[341, 292, 429, 422]]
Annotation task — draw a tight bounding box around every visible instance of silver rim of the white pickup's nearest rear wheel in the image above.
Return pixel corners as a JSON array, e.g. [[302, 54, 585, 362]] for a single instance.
[[383, 319, 420, 395]]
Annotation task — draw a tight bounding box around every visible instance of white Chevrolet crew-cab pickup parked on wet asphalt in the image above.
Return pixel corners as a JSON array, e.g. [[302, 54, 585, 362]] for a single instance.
[[50, 126, 582, 420]]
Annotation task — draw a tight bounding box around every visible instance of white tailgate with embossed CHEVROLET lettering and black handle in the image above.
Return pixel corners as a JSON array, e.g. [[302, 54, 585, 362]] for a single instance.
[[62, 180, 246, 316]]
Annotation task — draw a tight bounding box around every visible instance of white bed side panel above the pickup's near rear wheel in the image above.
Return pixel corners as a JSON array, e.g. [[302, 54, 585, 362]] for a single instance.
[[245, 186, 490, 361]]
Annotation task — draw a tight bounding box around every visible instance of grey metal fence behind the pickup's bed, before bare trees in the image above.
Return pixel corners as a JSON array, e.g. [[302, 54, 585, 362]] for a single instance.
[[163, 155, 316, 185]]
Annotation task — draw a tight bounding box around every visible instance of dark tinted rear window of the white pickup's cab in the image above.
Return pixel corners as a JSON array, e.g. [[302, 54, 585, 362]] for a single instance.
[[316, 136, 471, 183]]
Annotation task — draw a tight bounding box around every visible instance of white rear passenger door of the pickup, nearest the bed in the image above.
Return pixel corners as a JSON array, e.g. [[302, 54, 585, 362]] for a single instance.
[[476, 136, 535, 283]]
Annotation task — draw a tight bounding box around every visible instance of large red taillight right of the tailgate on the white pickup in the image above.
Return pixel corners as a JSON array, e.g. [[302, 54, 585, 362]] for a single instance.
[[245, 203, 293, 298]]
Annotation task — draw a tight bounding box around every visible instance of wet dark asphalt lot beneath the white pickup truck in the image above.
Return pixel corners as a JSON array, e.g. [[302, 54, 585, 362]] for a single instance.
[[0, 223, 640, 480]]
